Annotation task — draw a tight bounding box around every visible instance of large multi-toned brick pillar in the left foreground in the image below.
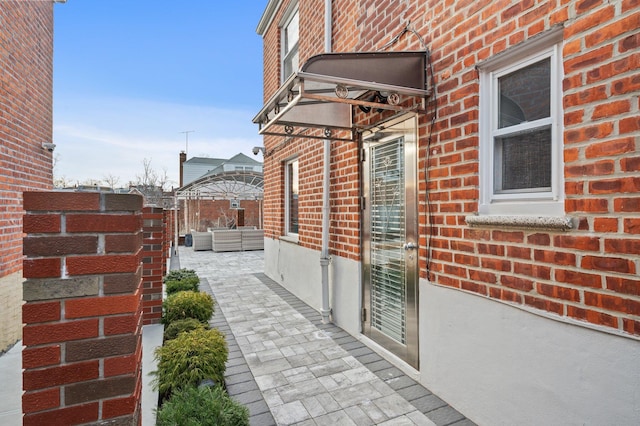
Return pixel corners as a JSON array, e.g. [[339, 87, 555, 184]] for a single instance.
[[22, 192, 142, 425]]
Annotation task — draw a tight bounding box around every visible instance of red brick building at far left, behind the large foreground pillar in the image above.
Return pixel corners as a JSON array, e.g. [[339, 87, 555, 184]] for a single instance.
[[0, 1, 54, 353]]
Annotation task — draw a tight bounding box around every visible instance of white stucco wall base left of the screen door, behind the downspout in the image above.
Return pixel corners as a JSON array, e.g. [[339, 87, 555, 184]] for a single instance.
[[264, 238, 361, 336]]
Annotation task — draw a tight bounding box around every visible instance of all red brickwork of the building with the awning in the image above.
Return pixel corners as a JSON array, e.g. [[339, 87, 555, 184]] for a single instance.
[[263, 0, 640, 335]]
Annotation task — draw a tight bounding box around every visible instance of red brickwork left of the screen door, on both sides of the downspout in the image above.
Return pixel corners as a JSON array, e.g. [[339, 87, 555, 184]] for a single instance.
[[264, 0, 360, 260]]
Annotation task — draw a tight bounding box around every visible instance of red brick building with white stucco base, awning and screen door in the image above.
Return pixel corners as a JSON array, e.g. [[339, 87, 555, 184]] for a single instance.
[[254, 0, 640, 424]]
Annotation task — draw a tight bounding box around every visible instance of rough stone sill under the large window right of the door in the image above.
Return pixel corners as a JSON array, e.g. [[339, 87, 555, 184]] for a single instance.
[[465, 215, 575, 231]]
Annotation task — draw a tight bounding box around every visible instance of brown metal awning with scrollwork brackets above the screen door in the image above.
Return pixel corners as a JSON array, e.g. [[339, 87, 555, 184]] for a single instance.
[[253, 51, 431, 140]]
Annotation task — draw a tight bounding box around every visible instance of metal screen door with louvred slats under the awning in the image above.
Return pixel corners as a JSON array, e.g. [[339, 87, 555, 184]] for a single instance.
[[363, 116, 418, 368]]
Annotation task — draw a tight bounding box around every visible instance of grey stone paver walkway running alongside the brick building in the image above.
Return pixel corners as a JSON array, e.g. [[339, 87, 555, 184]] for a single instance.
[[172, 247, 474, 426]]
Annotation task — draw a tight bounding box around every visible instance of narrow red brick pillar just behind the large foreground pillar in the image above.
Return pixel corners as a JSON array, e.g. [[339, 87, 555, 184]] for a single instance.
[[142, 207, 166, 325]]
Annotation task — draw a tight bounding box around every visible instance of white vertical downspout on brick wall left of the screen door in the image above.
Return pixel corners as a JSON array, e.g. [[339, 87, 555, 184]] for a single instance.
[[320, 0, 332, 324]]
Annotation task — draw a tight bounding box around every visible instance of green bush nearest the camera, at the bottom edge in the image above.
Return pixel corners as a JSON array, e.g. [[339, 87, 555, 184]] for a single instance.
[[156, 386, 249, 426]]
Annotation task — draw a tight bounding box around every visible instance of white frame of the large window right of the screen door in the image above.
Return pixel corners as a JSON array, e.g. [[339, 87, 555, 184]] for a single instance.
[[478, 31, 564, 216]]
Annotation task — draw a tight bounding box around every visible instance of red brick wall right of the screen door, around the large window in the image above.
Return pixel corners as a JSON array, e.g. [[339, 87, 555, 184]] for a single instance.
[[412, 1, 640, 335]]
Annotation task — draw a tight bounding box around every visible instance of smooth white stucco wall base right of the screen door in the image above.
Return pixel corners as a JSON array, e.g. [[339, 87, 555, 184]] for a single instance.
[[420, 280, 640, 425]]
